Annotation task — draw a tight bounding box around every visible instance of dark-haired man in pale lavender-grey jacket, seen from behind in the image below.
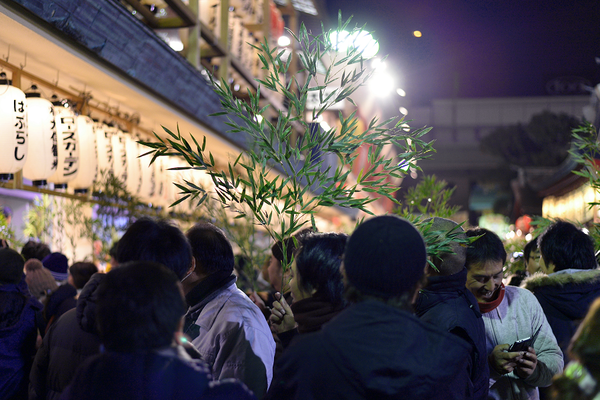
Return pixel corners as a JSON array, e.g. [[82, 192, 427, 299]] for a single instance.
[[181, 223, 275, 399]]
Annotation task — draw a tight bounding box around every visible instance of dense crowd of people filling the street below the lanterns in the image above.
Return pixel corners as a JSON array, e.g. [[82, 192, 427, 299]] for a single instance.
[[0, 216, 600, 400]]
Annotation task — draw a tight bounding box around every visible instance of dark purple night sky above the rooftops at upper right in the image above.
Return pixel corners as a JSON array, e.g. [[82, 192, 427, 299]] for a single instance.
[[326, 0, 600, 104]]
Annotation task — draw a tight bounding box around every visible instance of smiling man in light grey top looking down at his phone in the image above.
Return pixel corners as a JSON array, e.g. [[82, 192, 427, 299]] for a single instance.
[[466, 228, 563, 399]]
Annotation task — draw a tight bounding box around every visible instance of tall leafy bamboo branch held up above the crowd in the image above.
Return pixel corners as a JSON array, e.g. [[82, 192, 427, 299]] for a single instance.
[[141, 14, 433, 278]]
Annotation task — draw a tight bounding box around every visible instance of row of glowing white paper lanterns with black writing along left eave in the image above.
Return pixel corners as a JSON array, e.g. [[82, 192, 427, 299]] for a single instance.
[[0, 73, 197, 212]]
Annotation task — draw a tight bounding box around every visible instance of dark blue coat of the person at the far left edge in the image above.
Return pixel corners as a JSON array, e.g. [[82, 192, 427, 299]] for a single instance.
[[0, 275, 42, 399]]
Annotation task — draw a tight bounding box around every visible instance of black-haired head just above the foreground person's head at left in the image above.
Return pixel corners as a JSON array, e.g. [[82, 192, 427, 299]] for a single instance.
[[117, 218, 192, 279]]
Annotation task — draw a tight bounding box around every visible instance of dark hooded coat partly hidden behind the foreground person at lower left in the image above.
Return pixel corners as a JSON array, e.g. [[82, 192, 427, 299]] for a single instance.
[[29, 274, 105, 400]]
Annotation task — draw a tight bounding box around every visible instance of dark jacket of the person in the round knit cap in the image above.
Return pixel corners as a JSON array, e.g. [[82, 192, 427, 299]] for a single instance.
[[266, 300, 469, 400]]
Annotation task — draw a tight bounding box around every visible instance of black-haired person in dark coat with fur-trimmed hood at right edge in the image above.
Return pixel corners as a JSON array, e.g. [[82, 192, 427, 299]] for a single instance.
[[524, 221, 600, 362]]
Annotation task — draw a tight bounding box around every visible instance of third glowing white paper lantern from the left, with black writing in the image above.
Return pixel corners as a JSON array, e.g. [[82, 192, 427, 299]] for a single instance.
[[48, 102, 79, 189]]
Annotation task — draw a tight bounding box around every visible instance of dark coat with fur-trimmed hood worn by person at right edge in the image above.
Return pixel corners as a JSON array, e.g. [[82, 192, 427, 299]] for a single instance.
[[523, 269, 600, 363]]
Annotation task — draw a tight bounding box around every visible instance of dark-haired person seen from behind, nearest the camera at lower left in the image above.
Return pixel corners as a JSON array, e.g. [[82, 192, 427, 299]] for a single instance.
[[61, 262, 254, 400]]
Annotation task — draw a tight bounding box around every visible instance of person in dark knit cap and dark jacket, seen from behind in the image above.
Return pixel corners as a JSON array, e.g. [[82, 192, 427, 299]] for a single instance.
[[267, 216, 470, 400]]
